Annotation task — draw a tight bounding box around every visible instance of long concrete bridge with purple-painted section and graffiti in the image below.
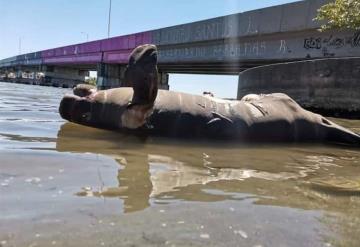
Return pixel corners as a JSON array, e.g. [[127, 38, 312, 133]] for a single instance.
[[0, 0, 360, 88]]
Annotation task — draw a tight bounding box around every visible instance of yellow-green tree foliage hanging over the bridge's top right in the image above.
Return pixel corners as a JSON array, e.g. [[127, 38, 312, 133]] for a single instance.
[[315, 0, 360, 30]]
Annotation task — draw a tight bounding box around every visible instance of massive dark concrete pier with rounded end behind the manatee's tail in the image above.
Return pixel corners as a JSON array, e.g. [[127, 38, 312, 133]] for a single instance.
[[237, 57, 360, 118]]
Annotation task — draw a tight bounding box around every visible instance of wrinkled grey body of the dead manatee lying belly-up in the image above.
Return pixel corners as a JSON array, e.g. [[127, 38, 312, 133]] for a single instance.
[[59, 45, 360, 146]]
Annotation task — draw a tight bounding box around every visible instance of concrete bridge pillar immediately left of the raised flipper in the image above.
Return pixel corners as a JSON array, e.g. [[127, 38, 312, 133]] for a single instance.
[[96, 63, 126, 89]]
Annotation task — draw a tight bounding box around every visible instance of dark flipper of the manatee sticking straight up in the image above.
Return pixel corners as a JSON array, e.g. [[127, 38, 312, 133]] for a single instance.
[[125, 44, 158, 107]]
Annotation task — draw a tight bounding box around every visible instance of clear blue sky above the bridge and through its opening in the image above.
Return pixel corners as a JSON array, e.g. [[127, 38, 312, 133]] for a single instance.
[[0, 0, 296, 98]]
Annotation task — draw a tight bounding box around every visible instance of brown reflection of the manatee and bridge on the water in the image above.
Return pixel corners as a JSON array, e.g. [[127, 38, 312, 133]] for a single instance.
[[56, 123, 360, 212]]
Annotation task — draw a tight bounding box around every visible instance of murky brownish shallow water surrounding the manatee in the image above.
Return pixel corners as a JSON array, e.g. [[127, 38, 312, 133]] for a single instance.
[[0, 83, 360, 247]]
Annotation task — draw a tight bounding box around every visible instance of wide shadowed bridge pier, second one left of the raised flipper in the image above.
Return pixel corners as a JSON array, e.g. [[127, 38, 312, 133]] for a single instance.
[[42, 66, 89, 87]]
